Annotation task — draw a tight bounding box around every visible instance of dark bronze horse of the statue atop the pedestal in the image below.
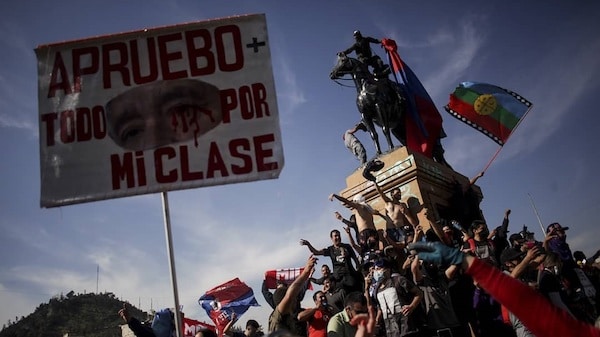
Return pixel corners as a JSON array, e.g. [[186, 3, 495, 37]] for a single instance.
[[329, 54, 406, 155]]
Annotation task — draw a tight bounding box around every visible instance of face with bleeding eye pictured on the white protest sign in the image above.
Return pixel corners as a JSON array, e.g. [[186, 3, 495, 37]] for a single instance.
[[106, 79, 223, 151]]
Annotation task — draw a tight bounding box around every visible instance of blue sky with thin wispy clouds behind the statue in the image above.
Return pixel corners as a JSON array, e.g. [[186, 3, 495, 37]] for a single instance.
[[0, 0, 600, 325]]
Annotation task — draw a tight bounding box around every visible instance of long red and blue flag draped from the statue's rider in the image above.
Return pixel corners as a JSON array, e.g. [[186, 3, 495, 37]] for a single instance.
[[381, 39, 442, 158]]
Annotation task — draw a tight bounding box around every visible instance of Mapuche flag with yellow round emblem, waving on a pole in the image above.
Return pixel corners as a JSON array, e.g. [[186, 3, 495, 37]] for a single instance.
[[445, 82, 531, 146]]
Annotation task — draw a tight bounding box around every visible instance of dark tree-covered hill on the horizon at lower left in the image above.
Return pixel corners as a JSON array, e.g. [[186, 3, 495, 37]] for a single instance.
[[0, 291, 148, 337]]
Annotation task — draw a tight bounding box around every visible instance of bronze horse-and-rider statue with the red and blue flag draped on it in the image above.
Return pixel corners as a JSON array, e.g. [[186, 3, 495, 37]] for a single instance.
[[329, 31, 450, 167]]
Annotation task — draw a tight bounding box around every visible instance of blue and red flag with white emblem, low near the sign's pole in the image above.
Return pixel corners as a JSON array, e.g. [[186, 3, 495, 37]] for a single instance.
[[198, 277, 259, 335]]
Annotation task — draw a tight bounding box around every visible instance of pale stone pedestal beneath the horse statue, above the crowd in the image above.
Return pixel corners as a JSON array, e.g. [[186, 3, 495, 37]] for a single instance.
[[340, 146, 483, 231]]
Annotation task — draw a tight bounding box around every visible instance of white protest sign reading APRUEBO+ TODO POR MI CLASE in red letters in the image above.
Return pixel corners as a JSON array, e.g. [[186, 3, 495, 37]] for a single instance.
[[36, 14, 284, 207]]
